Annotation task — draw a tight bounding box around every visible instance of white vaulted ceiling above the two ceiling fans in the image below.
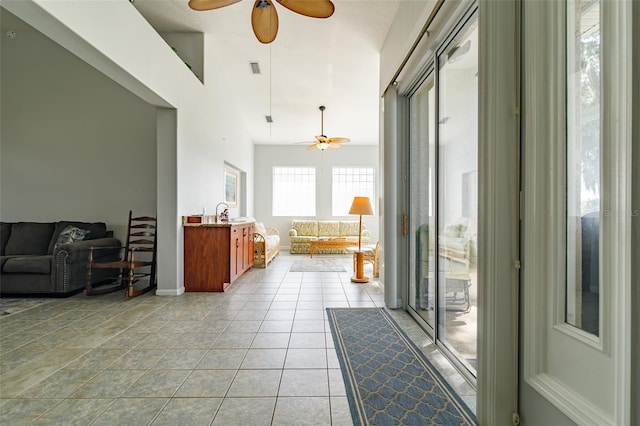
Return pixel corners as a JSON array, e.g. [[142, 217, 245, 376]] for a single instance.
[[134, 0, 400, 145]]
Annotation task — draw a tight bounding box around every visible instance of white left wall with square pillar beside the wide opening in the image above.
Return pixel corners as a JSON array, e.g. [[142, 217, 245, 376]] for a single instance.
[[3, 0, 253, 295]]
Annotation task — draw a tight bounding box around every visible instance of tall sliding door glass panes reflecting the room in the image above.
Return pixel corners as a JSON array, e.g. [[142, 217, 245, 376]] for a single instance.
[[409, 18, 478, 376]]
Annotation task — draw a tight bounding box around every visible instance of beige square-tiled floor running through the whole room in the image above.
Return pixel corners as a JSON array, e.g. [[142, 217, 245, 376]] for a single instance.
[[0, 253, 475, 425]]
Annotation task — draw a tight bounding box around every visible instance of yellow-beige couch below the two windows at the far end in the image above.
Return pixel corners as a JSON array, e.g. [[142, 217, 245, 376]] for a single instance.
[[289, 220, 371, 254]]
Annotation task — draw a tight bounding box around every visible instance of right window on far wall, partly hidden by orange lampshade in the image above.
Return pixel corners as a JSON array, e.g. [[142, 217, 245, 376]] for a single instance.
[[331, 167, 375, 216]]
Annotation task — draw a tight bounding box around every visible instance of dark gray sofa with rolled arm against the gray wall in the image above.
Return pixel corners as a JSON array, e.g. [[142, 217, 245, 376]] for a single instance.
[[0, 221, 121, 295]]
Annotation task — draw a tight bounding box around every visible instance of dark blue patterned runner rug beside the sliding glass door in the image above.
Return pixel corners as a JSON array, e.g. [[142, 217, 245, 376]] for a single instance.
[[327, 308, 476, 425]]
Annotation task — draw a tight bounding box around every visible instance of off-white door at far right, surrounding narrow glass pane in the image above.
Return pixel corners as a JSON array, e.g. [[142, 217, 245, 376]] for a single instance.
[[522, 0, 632, 425]]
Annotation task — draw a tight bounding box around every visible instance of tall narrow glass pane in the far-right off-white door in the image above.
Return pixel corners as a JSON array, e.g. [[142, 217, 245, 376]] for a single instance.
[[566, 0, 600, 335]]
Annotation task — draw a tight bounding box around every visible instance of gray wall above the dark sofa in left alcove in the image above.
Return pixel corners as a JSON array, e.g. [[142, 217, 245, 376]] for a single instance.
[[0, 10, 156, 239]]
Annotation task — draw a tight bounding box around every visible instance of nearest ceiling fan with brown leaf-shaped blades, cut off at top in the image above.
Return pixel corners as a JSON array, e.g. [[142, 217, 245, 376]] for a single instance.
[[189, 0, 335, 44]]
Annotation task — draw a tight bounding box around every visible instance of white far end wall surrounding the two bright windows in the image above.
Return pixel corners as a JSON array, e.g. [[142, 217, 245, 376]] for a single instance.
[[254, 145, 379, 249]]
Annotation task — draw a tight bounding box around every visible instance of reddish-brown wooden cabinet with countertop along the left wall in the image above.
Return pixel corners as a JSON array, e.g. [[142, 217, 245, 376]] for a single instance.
[[184, 222, 255, 291]]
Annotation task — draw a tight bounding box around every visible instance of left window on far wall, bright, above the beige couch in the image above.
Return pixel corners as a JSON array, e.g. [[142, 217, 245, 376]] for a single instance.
[[273, 167, 316, 216]]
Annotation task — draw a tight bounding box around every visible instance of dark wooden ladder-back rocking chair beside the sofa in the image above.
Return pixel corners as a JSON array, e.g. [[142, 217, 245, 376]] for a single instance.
[[85, 211, 157, 297]]
